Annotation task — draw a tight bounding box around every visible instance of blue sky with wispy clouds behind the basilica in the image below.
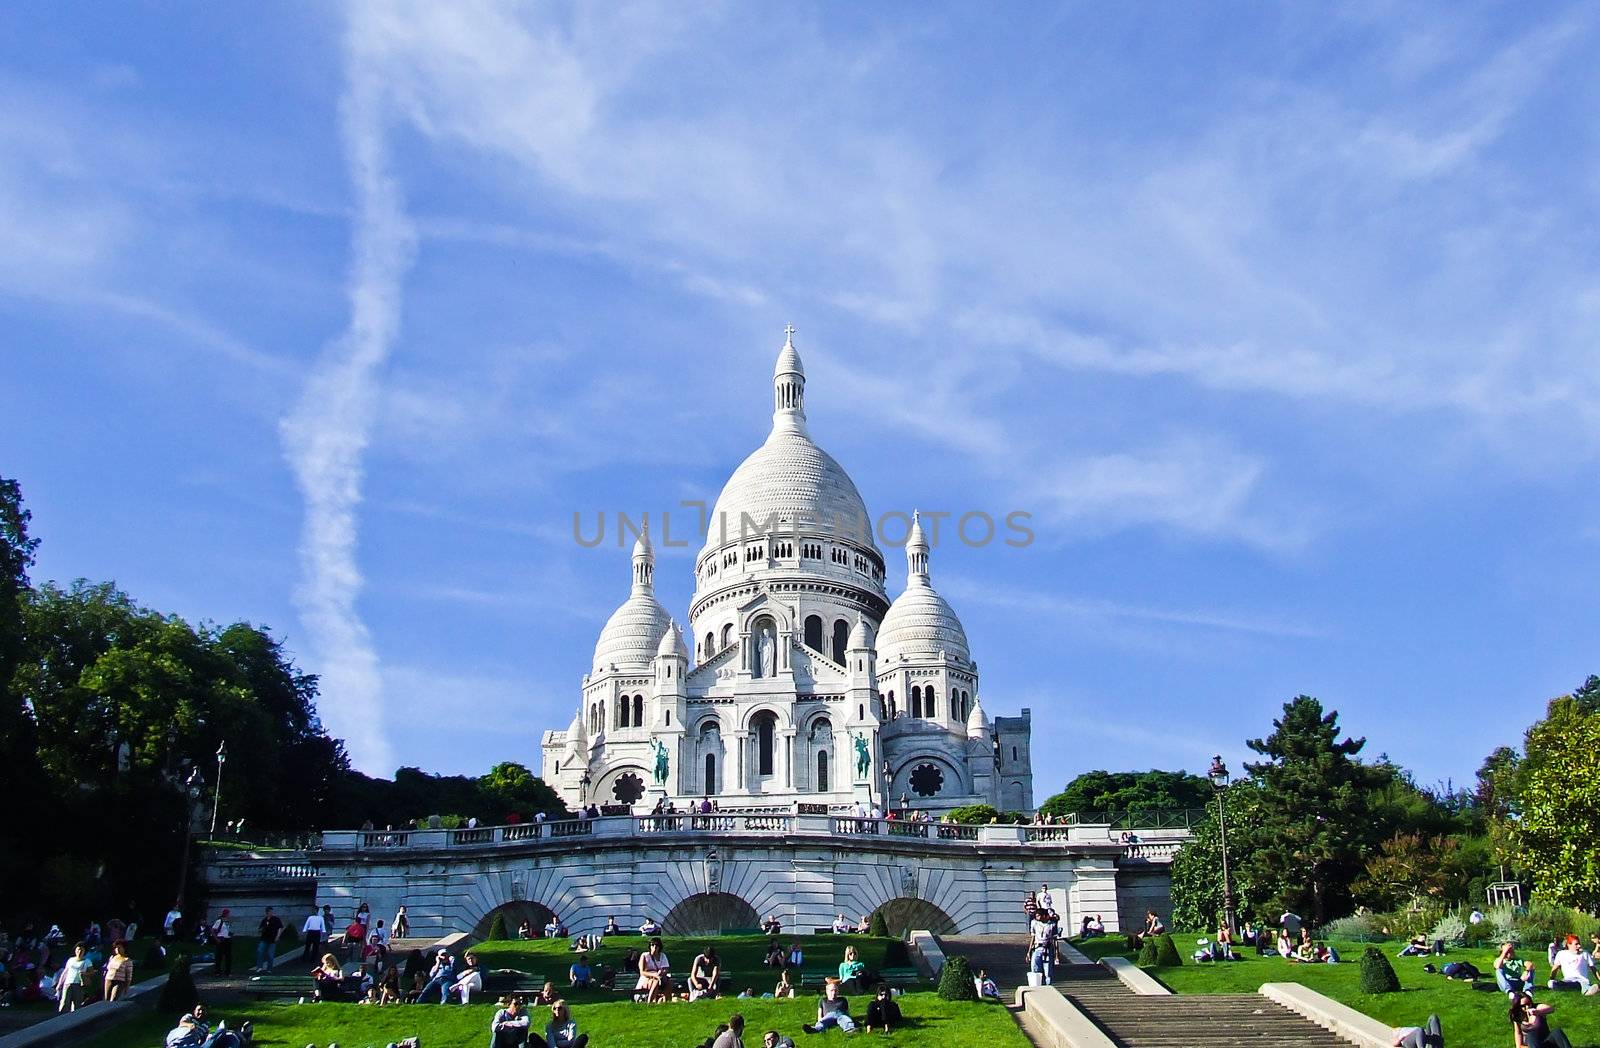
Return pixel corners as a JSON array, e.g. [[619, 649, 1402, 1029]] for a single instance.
[[0, 3, 1600, 797]]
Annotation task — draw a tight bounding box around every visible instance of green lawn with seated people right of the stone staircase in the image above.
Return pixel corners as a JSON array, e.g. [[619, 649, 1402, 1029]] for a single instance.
[[1074, 934, 1600, 1045]]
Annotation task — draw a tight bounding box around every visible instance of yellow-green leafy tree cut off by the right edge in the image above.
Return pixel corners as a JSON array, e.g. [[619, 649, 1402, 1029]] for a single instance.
[[1515, 697, 1600, 910]]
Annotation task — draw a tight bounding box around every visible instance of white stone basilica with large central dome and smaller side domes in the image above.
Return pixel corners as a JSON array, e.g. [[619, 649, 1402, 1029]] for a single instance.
[[542, 330, 1034, 811]]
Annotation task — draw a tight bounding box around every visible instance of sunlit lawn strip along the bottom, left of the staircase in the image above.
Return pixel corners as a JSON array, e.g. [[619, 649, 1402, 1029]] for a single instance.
[[86, 994, 1029, 1048]]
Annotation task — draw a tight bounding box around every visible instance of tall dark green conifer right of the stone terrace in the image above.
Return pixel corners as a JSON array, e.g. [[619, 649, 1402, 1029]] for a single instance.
[[1245, 694, 1381, 923]]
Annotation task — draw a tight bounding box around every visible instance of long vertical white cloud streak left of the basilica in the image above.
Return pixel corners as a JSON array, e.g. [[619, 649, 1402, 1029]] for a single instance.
[[282, 14, 414, 773]]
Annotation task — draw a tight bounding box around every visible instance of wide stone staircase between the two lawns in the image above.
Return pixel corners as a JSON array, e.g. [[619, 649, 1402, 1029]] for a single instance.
[[939, 936, 1349, 1048]]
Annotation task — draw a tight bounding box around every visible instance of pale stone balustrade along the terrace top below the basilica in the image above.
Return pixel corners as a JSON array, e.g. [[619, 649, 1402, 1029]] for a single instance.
[[322, 810, 1132, 862]]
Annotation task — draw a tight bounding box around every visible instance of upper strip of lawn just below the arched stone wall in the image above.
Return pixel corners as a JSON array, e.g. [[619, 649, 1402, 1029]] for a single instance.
[[472, 934, 909, 1002]]
